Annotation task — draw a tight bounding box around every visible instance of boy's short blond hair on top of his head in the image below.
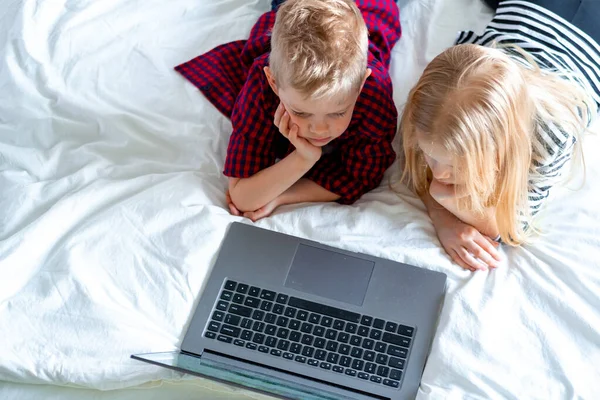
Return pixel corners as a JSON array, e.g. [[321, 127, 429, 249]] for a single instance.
[[269, 0, 369, 99]]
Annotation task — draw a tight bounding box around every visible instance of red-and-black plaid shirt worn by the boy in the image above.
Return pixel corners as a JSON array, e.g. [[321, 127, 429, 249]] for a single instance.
[[175, 0, 401, 204]]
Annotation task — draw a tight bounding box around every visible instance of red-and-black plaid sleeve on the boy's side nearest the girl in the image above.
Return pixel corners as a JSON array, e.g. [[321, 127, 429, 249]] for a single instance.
[[305, 58, 398, 204]]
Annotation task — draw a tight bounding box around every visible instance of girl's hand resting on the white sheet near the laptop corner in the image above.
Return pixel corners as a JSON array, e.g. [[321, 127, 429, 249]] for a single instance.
[[432, 209, 500, 271]]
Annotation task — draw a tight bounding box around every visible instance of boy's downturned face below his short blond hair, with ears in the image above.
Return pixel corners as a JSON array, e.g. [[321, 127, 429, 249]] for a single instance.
[[267, 70, 371, 147]]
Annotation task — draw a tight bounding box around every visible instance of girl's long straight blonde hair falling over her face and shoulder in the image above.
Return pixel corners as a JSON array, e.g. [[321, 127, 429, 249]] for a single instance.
[[400, 44, 590, 245]]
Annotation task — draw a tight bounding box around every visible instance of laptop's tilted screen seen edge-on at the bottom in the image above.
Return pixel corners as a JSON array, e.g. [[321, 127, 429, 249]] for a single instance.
[[131, 351, 352, 400]]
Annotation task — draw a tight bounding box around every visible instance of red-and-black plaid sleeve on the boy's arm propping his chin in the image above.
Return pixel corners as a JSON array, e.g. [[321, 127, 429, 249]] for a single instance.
[[223, 57, 279, 178]]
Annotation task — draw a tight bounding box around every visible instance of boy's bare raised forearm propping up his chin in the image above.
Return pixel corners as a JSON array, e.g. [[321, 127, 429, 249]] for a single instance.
[[229, 151, 313, 212]]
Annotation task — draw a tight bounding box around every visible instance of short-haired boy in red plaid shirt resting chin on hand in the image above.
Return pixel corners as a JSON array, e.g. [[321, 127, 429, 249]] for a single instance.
[[176, 0, 400, 221]]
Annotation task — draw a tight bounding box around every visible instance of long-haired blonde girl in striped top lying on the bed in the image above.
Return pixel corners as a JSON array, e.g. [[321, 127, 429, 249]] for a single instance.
[[401, 0, 600, 271]]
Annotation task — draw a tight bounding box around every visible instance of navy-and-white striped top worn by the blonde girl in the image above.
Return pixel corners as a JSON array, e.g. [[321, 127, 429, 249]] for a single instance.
[[456, 0, 600, 215]]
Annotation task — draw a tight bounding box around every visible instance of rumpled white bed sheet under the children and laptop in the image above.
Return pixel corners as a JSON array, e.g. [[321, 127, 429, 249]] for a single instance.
[[0, 0, 600, 399]]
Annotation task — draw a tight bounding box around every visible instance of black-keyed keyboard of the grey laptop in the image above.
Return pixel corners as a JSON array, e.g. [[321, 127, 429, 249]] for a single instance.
[[204, 280, 414, 388]]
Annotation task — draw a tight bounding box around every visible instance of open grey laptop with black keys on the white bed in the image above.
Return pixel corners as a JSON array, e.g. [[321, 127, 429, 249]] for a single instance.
[[131, 222, 446, 400]]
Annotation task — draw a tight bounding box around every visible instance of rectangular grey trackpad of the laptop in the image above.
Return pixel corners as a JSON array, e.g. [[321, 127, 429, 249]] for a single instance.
[[285, 244, 375, 306]]
